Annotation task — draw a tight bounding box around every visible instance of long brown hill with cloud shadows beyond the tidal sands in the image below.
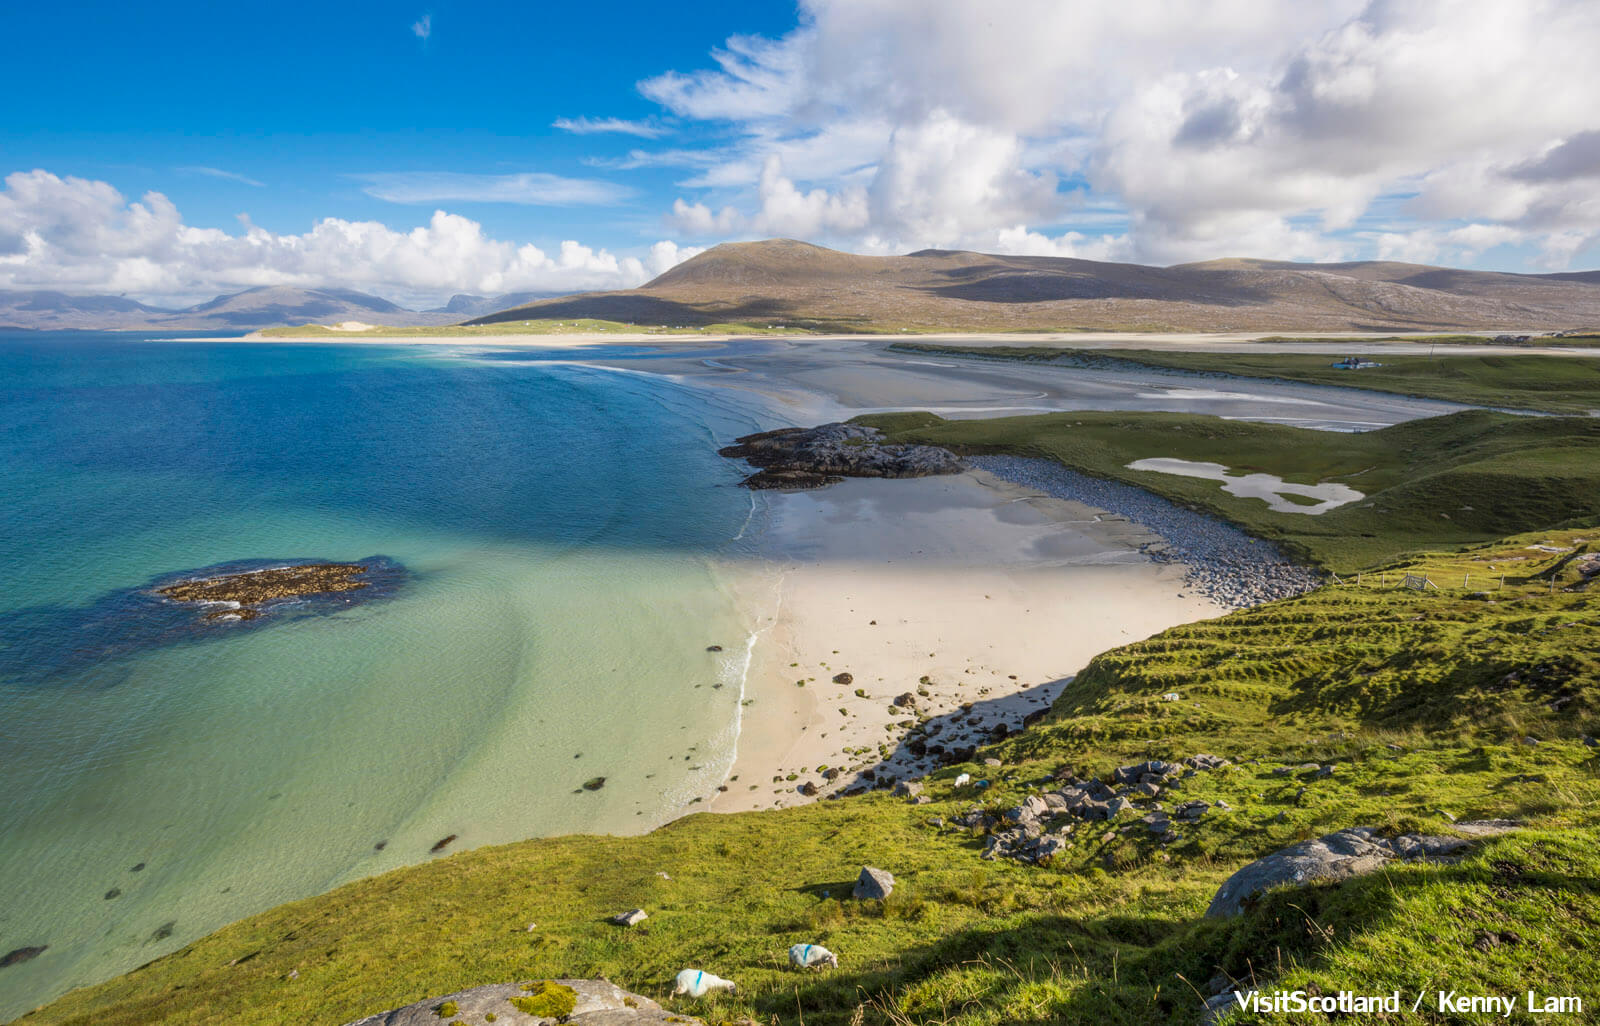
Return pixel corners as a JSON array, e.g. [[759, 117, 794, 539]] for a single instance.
[[467, 238, 1600, 331]]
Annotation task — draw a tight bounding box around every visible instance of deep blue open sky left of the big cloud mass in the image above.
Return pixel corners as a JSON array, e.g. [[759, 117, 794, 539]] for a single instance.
[[0, 2, 795, 246]]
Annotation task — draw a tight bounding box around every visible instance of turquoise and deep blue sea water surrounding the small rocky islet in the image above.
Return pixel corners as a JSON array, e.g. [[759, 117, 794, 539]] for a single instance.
[[0, 335, 760, 1018]]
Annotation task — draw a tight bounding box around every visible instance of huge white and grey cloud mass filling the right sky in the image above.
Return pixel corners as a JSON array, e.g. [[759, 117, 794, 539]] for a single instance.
[[640, 0, 1600, 261]]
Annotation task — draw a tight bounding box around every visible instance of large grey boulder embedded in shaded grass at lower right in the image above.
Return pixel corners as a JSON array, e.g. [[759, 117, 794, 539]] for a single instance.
[[1205, 820, 1520, 919]]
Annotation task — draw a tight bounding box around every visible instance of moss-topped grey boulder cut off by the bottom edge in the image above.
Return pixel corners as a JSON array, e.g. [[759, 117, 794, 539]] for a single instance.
[[346, 980, 704, 1026]]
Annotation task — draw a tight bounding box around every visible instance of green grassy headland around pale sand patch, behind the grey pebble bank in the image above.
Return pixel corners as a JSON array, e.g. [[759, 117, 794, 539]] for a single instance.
[[858, 410, 1600, 573]]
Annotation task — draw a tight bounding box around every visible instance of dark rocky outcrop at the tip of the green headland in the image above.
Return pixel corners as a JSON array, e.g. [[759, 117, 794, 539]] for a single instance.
[[717, 424, 966, 488]]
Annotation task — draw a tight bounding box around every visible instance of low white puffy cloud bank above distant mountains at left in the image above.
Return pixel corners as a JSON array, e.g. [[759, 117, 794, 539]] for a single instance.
[[0, 171, 699, 303]]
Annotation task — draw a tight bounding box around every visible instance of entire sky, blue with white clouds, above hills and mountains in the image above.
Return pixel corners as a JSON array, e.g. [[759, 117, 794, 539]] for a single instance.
[[0, 0, 1600, 303]]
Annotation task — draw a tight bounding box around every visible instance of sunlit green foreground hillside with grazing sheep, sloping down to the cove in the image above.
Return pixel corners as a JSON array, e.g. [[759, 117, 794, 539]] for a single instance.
[[22, 528, 1600, 1026]]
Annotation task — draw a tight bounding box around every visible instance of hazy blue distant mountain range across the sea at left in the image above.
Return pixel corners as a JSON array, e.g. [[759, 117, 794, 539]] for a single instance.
[[0, 287, 563, 331]]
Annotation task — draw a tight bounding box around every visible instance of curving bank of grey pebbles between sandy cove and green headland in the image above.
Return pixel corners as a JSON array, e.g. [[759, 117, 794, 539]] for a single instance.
[[966, 456, 1323, 610]]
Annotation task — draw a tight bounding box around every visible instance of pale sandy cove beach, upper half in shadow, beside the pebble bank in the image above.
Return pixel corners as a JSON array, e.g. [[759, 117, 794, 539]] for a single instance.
[[710, 472, 1222, 812]]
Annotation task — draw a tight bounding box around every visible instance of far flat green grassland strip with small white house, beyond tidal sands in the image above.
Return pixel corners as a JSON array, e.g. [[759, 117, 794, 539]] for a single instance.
[[891, 338, 1600, 415]]
